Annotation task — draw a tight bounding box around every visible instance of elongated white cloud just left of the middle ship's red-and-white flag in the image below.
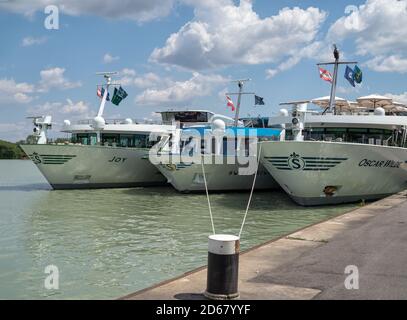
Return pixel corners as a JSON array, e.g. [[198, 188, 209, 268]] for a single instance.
[[135, 73, 227, 105]]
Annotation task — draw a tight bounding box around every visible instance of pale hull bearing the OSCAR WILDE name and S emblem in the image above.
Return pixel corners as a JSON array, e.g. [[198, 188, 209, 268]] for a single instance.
[[261, 141, 407, 206]]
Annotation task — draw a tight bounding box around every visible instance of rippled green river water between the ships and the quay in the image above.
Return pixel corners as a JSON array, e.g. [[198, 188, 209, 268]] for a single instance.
[[0, 160, 356, 299]]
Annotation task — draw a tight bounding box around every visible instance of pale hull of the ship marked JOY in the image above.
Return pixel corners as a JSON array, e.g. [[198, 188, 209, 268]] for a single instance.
[[21, 145, 166, 189]]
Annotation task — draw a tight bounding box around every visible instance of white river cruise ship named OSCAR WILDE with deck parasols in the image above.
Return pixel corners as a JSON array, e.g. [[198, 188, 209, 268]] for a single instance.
[[261, 97, 407, 205]]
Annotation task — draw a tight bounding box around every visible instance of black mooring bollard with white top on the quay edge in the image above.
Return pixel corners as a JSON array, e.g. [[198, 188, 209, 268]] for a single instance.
[[204, 234, 240, 300]]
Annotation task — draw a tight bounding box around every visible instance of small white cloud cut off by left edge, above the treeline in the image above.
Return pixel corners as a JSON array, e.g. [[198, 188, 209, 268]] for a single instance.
[[0, 78, 35, 104]]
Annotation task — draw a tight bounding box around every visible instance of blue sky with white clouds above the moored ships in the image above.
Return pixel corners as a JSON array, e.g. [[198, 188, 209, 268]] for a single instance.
[[0, 0, 407, 141]]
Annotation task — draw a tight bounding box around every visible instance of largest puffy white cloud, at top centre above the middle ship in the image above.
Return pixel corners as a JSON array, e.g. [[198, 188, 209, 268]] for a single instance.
[[150, 0, 326, 70]]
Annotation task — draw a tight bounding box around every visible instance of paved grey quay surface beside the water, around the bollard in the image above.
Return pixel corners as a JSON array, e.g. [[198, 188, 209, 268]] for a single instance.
[[122, 191, 407, 300]]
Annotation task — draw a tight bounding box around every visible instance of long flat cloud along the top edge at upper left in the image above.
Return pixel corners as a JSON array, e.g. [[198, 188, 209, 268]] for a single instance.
[[0, 0, 175, 22]]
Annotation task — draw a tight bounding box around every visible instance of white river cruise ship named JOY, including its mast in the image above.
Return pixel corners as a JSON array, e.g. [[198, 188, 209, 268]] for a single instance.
[[21, 73, 226, 189]]
